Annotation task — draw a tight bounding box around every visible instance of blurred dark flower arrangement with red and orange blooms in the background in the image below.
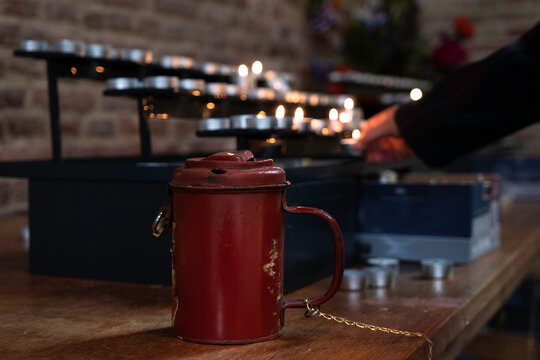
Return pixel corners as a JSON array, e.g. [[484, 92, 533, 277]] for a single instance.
[[308, 0, 475, 79]]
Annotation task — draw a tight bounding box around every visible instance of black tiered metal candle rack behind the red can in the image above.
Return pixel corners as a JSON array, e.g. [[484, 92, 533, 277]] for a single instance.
[[0, 50, 414, 291]]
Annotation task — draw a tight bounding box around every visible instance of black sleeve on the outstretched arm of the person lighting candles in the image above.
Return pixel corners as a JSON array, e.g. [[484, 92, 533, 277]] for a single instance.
[[396, 23, 540, 166]]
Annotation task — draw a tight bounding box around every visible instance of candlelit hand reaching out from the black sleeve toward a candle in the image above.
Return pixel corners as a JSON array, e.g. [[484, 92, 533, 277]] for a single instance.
[[354, 106, 414, 164]]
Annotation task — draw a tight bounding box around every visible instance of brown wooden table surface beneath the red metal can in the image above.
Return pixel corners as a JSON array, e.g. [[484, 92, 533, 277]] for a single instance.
[[0, 203, 540, 360]]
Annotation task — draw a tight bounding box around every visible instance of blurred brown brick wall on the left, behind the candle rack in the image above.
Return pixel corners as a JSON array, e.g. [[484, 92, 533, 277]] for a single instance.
[[0, 0, 308, 214]]
